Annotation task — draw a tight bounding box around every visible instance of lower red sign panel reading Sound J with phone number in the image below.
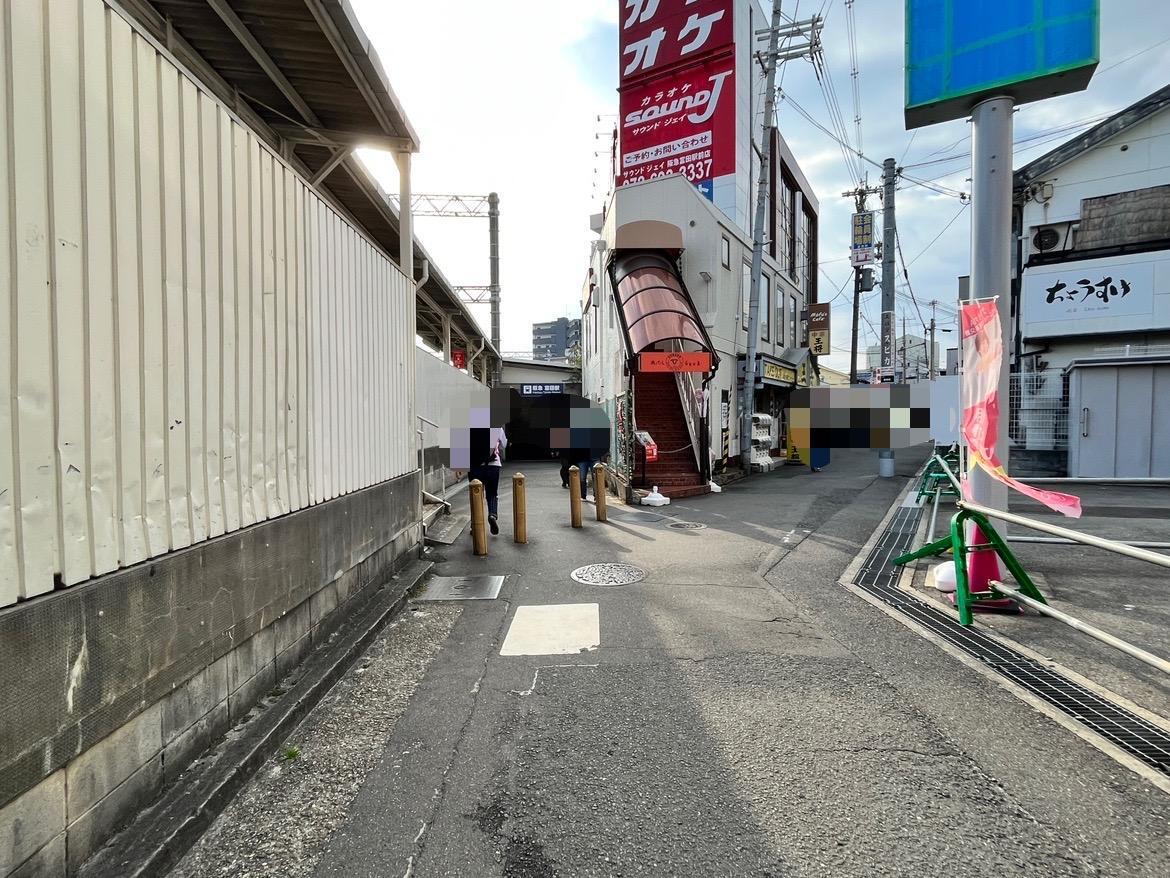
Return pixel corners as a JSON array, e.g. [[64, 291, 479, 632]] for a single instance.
[[619, 55, 736, 191]]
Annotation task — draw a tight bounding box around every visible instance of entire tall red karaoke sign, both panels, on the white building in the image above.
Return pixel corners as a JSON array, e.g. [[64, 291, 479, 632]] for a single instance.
[[618, 0, 736, 199]]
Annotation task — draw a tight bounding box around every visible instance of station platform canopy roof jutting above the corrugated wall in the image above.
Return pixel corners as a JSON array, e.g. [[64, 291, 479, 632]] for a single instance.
[[118, 0, 498, 356]]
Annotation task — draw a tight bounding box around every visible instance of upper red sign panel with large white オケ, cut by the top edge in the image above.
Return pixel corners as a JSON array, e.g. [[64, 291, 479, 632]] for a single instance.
[[618, 0, 735, 81]]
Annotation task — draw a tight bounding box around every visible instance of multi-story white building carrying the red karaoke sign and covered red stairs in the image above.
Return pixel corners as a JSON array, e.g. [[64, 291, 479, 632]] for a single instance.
[[581, 0, 819, 496]]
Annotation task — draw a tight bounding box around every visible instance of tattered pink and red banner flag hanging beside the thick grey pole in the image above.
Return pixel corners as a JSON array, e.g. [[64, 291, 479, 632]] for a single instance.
[[959, 300, 1081, 519]]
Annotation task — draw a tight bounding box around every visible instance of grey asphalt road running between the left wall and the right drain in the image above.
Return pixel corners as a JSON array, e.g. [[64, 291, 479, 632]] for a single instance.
[[174, 452, 1170, 878]]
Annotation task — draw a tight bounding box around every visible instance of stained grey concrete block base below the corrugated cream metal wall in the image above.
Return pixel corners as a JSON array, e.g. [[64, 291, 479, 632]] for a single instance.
[[0, 472, 420, 878]]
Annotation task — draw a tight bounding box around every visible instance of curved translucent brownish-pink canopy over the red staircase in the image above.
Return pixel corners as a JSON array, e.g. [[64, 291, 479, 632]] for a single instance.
[[611, 252, 718, 365]]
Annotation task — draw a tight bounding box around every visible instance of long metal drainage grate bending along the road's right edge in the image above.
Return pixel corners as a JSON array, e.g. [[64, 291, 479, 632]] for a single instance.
[[854, 507, 1170, 775]]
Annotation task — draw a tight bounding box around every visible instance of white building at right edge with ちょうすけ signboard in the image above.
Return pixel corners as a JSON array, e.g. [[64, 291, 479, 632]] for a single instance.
[[1012, 87, 1170, 476]]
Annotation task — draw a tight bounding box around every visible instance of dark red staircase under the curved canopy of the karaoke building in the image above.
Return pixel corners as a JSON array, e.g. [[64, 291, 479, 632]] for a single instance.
[[633, 372, 710, 498]]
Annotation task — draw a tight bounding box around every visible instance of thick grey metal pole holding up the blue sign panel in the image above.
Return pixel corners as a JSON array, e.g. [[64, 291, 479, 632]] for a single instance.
[[970, 97, 1013, 522]]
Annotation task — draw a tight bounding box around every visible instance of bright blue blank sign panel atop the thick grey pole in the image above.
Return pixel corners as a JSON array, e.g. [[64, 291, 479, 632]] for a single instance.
[[906, 0, 1100, 129]]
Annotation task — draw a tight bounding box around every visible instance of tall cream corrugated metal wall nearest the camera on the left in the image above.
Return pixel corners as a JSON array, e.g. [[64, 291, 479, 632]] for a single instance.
[[0, 0, 417, 605]]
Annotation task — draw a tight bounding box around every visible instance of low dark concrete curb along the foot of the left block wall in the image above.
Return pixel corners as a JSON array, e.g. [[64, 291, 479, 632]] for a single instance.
[[77, 561, 433, 878]]
